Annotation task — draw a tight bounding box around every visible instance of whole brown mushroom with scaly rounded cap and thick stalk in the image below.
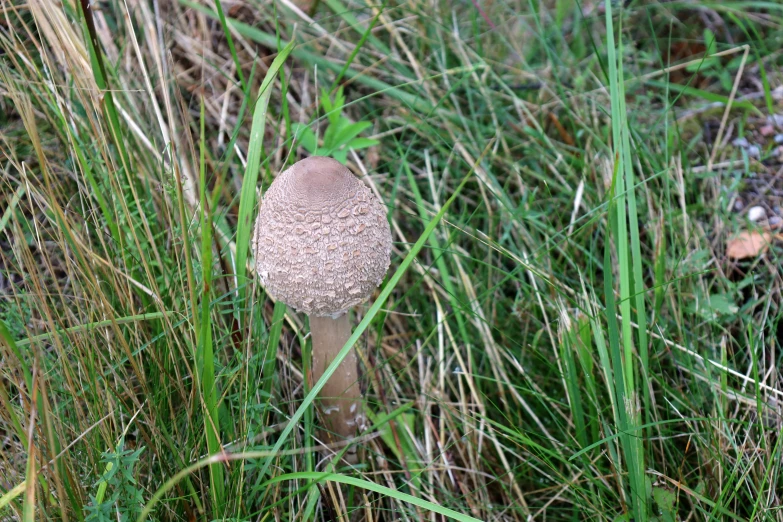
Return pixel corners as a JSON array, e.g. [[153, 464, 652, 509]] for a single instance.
[[253, 156, 391, 462]]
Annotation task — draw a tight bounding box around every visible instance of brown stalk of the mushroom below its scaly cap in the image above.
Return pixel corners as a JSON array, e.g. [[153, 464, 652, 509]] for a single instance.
[[310, 314, 364, 463]]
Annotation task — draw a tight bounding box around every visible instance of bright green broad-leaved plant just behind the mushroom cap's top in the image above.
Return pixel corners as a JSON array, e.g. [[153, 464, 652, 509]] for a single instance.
[[293, 87, 378, 164]]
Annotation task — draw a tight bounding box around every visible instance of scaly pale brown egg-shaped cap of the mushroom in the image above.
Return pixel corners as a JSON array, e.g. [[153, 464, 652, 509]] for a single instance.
[[253, 156, 391, 316]]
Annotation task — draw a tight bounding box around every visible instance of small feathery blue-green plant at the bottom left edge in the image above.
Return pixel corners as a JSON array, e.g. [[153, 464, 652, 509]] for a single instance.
[[85, 440, 144, 522]]
